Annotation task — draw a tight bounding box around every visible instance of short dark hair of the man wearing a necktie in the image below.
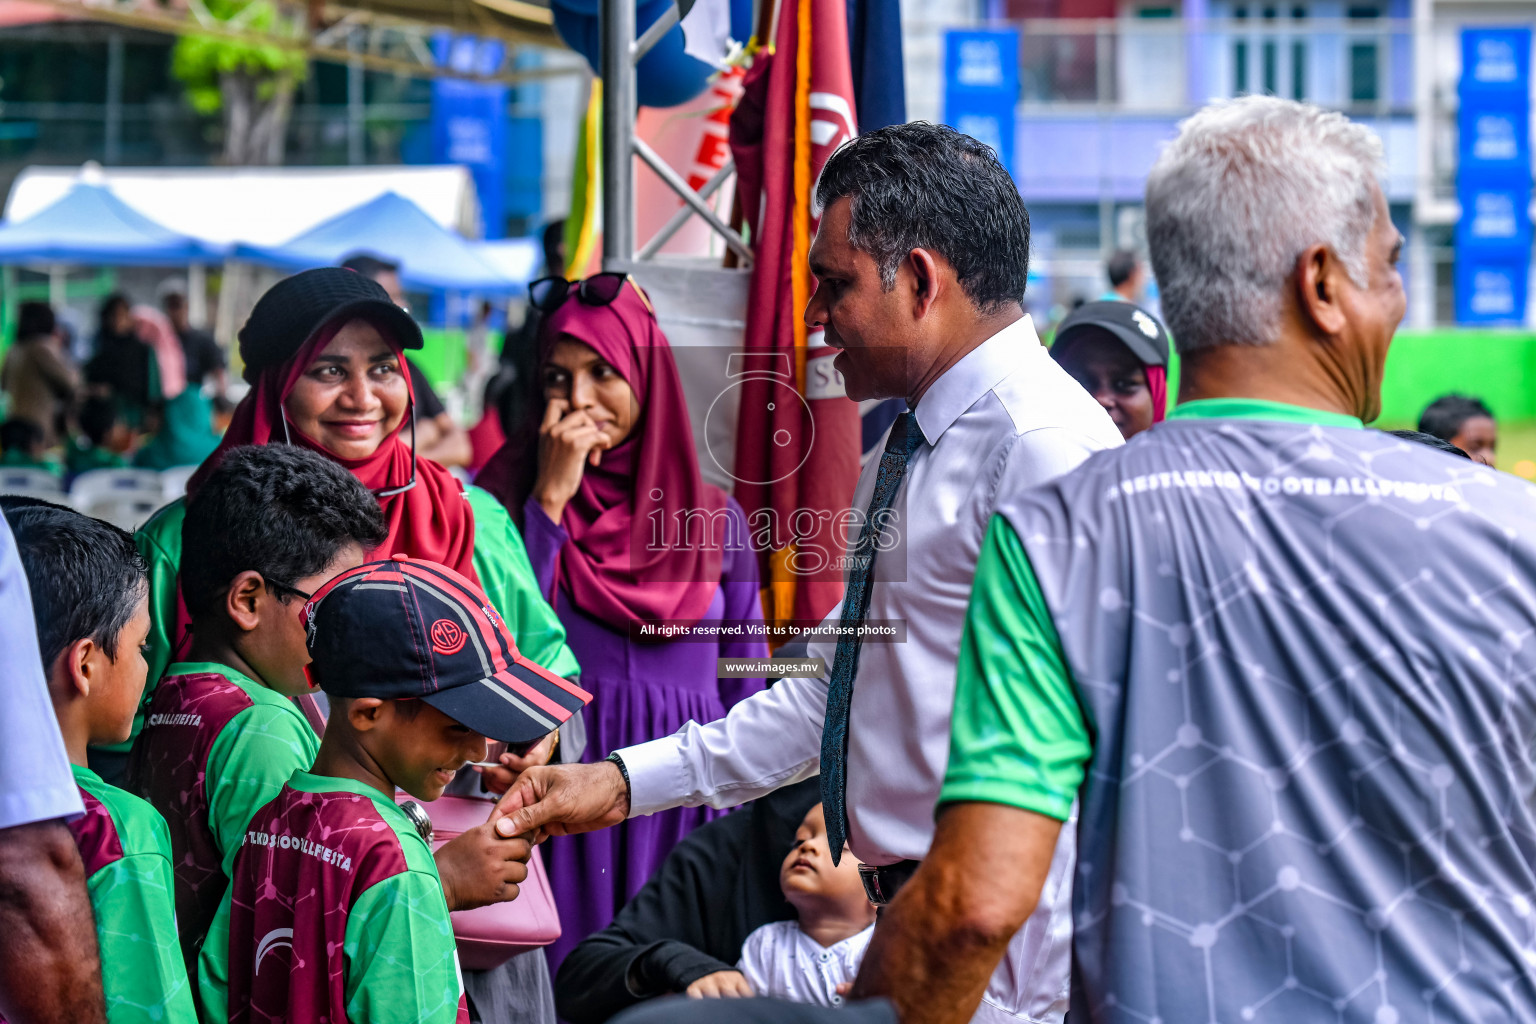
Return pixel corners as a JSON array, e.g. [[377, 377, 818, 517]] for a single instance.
[[816, 121, 1029, 313]]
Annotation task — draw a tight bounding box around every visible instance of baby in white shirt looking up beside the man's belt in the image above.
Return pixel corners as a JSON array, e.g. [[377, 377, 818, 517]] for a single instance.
[[736, 804, 876, 1006]]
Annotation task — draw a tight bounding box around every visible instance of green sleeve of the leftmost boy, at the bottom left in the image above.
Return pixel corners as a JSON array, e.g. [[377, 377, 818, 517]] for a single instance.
[[86, 820, 197, 1024]]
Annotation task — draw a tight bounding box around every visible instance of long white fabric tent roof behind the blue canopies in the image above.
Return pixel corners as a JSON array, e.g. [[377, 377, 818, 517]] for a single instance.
[[5, 164, 479, 246]]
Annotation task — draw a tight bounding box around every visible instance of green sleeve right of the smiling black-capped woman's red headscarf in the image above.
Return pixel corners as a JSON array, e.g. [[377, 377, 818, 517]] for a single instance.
[[465, 487, 581, 679]]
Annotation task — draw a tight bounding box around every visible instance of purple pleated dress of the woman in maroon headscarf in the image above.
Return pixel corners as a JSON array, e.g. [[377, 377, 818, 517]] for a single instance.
[[524, 497, 768, 976]]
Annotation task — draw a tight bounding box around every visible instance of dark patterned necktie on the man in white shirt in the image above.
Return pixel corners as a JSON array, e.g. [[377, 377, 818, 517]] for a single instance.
[[822, 413, 923, 864]]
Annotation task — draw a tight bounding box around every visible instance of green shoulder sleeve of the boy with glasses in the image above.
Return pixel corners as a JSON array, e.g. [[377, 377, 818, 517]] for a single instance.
[[203, 705, 319, 878]]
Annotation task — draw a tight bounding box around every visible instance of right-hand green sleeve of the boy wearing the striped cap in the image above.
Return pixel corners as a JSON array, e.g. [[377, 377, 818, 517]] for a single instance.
[[343, 870, 464, 1024]]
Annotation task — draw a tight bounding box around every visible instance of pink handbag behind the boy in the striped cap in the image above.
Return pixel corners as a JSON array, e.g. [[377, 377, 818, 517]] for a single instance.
[[293, 694, 561, 970]]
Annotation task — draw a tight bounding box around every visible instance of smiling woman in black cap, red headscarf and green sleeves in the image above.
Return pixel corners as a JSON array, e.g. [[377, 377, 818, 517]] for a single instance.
[[137, 267, 585, 1024]]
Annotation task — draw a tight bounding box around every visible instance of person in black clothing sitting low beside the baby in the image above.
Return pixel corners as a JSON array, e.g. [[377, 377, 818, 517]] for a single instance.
[[554, 778, 822, 1024]]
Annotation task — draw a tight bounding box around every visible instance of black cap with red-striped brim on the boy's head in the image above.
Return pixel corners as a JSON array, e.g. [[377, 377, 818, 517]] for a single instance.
[[304, 556, 591, 745]]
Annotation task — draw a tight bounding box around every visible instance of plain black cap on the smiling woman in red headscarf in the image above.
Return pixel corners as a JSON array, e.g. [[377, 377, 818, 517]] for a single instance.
[[240, 267, 422, 384]]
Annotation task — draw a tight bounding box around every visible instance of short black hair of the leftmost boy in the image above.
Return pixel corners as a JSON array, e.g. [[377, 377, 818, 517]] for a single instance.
[[5, 502, 149, 672]]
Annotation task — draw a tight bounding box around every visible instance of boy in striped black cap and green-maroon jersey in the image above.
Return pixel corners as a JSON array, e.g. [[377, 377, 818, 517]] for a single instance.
[[198, 557, 590, 1024]]
